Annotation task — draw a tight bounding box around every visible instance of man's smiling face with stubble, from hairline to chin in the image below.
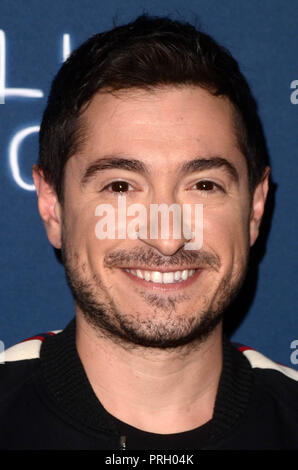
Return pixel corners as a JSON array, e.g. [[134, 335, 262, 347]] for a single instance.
[[57, 87, 260, 347]]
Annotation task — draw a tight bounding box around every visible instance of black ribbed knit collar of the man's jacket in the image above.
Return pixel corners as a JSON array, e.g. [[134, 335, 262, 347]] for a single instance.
[[40, 319, 253, 443]]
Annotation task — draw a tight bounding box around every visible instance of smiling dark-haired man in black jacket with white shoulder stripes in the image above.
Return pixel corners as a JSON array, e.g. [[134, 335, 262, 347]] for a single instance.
[[0, 16, 298, 450]]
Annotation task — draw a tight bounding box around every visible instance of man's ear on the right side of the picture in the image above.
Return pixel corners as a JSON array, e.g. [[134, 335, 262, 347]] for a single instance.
[[250, 166, 270, 246]]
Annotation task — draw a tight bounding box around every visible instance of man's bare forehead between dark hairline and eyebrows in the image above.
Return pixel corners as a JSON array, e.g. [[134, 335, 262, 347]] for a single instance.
[[68, 86, 246, 179]]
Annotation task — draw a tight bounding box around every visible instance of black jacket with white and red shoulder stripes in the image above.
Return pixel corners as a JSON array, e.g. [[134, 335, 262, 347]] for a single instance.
[[0, 320, 298, 450]]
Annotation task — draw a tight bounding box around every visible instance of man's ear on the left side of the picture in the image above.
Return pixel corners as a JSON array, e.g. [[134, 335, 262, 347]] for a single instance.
[[32, 165, 62, 249]]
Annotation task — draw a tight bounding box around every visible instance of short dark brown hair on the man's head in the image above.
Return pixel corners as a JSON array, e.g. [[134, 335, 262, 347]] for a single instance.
[[38, 15, 268, 204]]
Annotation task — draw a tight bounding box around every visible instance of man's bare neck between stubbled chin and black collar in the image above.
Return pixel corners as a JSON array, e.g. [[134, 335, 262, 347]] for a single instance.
[[76, 313, 222, 434]]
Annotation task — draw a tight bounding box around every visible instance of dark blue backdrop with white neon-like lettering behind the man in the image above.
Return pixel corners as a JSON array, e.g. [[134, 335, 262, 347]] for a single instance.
[[0, 0, 298, 368]]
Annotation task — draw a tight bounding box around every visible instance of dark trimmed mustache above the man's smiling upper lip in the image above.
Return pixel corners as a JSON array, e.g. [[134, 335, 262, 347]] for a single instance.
[[104, 248, 221, 271]]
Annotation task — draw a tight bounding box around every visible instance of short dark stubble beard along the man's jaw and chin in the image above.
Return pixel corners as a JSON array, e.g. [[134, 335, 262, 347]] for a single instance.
[[61, 232, 247, 350]]
